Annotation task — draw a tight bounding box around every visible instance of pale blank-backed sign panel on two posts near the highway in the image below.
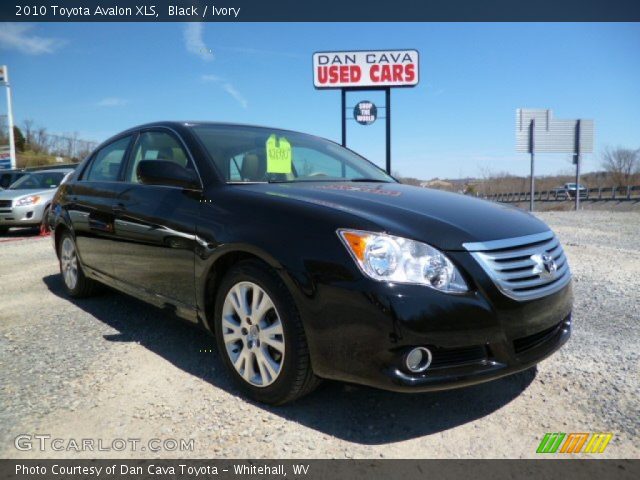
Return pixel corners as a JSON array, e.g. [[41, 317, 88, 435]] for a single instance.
[[516, 108, 594, 153]]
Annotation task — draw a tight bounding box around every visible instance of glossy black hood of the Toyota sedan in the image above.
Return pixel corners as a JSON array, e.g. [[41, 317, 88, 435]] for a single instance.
[[240, 182, 549, 250]]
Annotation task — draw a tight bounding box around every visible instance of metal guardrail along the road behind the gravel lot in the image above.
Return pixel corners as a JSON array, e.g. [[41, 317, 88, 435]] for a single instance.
[[482, 185, 640, 203]]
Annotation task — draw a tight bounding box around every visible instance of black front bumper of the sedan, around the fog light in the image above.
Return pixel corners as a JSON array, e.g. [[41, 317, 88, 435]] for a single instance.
[[301, 256, 573, 391]]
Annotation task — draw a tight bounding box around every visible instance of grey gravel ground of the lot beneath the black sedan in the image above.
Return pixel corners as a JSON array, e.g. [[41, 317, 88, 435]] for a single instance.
[[0, 211, 640, 458]]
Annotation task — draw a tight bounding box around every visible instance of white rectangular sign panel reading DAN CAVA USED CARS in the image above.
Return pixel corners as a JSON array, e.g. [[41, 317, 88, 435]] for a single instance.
[[313, 50, 419, 88]]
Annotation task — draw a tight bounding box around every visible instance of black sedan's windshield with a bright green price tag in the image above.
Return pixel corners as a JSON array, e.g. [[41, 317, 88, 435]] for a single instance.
[[191, 124, 395, 183]]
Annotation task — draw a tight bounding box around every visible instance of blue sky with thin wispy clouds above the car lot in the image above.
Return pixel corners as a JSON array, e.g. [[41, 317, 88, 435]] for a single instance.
[[0, 23, 640, 179]]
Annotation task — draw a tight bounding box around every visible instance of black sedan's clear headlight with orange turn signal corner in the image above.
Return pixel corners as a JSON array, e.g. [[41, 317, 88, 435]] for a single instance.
[[338, 230, 469, 293]]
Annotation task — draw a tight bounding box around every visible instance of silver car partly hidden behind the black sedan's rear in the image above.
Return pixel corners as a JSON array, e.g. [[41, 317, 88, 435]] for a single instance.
[[0, 169, 73, 233]]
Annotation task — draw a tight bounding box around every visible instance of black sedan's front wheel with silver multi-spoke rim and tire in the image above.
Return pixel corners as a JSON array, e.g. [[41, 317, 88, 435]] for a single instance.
[[214, 261, 319, 405]]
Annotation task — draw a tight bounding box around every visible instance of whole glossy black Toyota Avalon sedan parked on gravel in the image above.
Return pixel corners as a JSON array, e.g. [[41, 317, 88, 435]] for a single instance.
[[47, 122, 573, 404]]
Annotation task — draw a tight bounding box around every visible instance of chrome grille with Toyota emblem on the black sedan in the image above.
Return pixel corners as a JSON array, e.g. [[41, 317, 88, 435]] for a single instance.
[[463, 231, 571, 300]]
